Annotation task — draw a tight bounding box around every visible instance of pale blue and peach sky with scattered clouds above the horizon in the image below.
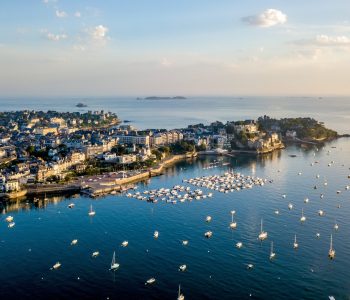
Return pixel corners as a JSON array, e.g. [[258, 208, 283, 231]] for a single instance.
[[0, 0, 350, 97]]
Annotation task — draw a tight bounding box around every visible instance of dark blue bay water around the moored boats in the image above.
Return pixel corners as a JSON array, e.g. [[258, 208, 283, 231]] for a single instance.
[[0, 139, 350, 300]]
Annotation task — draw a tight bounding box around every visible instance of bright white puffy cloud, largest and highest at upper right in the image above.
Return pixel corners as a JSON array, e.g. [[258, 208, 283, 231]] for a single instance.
[[242, 8, 287, 28]]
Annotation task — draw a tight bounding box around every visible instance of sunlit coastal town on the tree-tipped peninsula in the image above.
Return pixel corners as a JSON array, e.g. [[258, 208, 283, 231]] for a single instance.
[[0, 110, 337, 198]]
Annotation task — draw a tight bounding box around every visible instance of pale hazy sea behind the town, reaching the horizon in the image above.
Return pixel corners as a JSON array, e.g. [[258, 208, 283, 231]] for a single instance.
[[0, 97, 350, 133]]
